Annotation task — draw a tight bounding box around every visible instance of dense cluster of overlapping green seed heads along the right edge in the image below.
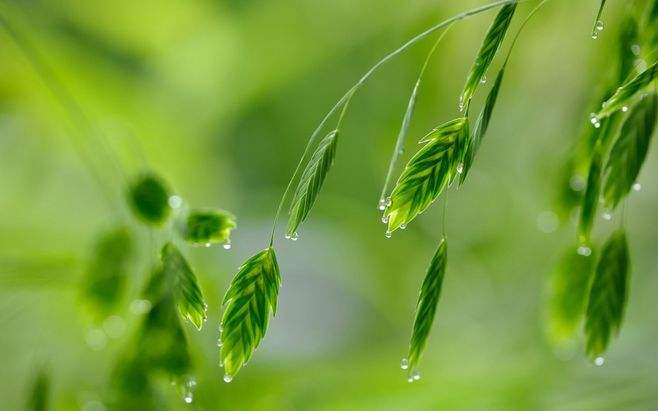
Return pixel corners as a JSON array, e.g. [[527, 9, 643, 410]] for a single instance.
[[551, 2, 658, 362]]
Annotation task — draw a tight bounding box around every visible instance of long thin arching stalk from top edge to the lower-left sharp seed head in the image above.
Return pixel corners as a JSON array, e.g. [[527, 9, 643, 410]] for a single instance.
[[270, 0, 516, 247]]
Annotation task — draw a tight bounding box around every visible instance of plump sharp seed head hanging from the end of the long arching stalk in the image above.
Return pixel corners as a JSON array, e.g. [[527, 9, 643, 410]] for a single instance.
[[220, 247, 281, 382]]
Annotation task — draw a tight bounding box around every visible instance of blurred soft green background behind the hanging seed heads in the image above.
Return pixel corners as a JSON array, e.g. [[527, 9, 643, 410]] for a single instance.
[[0, 0, 658, 411]]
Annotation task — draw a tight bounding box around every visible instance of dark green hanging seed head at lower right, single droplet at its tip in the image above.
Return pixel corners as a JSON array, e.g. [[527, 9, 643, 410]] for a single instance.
[[585, 229, 629, 358]]
